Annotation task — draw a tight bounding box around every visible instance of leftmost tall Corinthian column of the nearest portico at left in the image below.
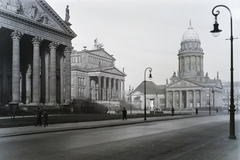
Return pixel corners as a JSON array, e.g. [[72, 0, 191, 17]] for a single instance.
[[11, 31, 23, 103]]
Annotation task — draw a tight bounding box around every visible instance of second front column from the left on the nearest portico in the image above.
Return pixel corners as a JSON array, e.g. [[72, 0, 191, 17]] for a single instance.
[[32, 37, 43, 104]]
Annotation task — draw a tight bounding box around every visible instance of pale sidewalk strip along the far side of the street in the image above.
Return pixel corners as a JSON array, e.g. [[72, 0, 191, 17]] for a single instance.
[[0, 115, 207, 138]]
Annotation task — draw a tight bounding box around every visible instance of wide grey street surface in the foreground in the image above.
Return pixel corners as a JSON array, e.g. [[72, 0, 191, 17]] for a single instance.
[[0, 115, 240, 160]]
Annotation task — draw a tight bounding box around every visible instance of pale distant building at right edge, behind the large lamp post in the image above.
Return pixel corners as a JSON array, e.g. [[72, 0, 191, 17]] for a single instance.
[[222, 82, 240, 109]]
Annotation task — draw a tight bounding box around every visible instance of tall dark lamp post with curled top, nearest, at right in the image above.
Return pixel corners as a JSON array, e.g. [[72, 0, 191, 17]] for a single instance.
[[210, 5, 236, 139]]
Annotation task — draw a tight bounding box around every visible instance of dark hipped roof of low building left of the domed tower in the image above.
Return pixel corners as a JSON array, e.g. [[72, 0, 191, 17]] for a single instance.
[[133, 81, 166, 94]]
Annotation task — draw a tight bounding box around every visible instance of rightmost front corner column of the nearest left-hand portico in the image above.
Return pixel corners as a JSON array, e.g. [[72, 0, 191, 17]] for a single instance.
[[64, 46, 73, 104]]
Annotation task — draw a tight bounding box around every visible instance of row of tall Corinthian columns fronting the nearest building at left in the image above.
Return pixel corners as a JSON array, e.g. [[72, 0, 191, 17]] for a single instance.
[[11, 31, 72, 105]]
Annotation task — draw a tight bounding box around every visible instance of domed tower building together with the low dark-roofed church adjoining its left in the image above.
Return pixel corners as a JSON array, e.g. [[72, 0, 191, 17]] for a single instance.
[[127, 24, 223, 110]]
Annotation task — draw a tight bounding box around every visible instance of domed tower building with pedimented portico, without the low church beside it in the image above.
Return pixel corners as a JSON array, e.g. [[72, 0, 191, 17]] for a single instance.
[[166, 24, 223, 109]]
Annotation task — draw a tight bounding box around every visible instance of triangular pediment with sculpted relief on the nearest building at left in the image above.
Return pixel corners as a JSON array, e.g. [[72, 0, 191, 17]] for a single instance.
[[0, 0, 76, 37]]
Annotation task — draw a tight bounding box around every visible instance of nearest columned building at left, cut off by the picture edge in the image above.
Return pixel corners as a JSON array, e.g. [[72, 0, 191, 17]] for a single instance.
[[0, 0, 76, 106]]
